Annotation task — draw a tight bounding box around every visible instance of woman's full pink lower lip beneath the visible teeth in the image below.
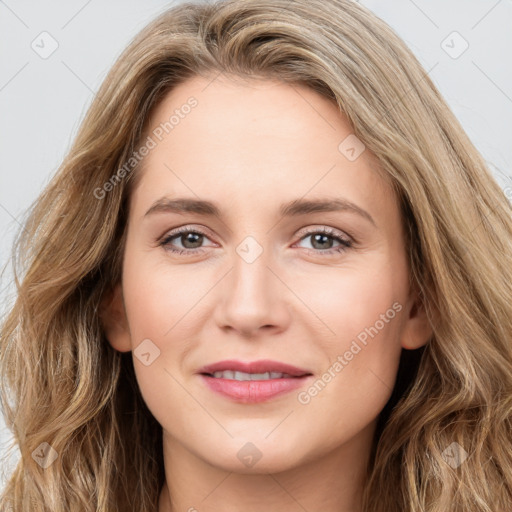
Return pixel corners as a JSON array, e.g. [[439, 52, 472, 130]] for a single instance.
[[201, 375, 311, 404]]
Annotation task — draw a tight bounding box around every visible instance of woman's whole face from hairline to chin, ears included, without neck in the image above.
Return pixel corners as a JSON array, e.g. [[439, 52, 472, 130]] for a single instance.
[[102, 77, 430, 472]]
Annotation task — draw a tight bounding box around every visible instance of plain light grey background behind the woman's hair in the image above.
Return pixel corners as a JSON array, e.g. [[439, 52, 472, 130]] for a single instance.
[[0, 0, 512, 486]]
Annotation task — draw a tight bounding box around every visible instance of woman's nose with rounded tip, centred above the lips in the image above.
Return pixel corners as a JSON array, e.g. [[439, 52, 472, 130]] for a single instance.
[[215, 252, 293, 338]]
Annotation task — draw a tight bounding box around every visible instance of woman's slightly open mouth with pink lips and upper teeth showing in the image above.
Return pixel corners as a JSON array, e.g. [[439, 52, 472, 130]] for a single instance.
[[198, 360, 313, 403]]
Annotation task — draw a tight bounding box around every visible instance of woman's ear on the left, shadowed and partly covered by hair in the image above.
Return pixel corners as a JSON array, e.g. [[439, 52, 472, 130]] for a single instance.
[[100, 283, 132, 352]]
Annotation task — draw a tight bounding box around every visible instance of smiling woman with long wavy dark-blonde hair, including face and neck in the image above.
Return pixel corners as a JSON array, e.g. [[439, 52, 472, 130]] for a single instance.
[[1, 0, 512, 512]]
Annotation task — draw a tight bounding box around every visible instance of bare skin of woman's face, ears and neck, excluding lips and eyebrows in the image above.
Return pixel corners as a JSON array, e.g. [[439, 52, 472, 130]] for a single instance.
[[104, 75, 432, 512]]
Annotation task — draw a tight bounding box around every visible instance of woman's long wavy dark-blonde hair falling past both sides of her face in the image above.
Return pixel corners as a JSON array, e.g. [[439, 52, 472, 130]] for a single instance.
[[0, 0, 512, 512]]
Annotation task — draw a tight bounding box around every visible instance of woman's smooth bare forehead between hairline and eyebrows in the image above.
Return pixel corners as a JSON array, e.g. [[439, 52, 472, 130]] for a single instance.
[[130, 75, 393, 224]]
